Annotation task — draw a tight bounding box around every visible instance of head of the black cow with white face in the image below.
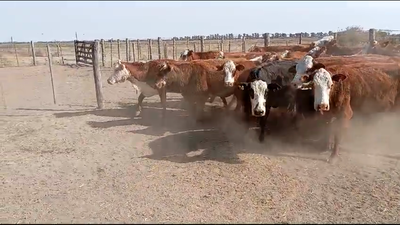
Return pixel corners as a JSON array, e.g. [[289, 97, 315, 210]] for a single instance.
[[238, 69, 281, 117]]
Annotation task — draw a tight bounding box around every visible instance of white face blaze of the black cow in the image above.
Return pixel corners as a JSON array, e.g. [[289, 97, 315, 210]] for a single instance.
[[249, 80, 268, 117]]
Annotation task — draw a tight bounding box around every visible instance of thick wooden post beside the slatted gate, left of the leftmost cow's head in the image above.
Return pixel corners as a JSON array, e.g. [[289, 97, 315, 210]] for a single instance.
[[92, 41, 104, 109]]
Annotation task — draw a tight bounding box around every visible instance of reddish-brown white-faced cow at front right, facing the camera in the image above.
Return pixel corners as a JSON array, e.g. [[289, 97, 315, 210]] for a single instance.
[[301, 63, 400, 161]]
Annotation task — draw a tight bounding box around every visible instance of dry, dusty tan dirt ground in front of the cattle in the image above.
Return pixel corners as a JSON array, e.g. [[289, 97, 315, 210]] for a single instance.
[[0, 63, 400, 223]]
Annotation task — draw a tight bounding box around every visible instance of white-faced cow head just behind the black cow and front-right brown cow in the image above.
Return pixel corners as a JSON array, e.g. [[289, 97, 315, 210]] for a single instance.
[[288, 55, 325, 89]]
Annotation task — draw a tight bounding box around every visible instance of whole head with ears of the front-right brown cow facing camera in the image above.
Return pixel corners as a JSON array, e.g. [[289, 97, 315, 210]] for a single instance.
[[301, 68, 347, 113]]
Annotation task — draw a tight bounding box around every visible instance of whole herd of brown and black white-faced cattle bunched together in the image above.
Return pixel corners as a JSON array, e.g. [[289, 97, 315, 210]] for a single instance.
[[107, 36, 400, 162]]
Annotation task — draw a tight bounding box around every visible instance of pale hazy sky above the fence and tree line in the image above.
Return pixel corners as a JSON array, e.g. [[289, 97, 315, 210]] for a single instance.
[[0, 1, 400, 42]]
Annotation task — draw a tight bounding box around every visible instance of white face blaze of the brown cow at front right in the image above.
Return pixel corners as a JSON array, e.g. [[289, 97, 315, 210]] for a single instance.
[[312, 68, 333, 111]]
